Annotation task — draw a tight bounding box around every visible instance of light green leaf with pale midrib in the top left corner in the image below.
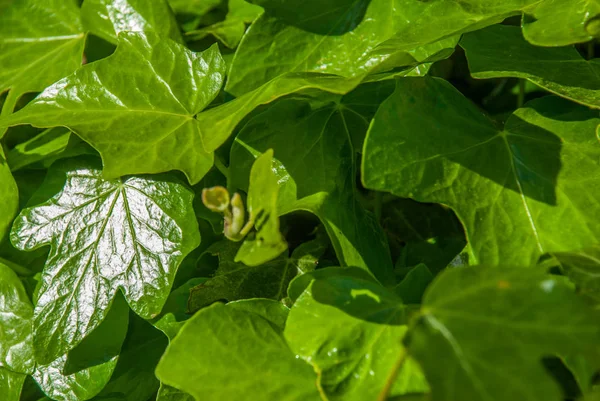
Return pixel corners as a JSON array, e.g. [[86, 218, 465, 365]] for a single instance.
[[0, 0, 85, 119]]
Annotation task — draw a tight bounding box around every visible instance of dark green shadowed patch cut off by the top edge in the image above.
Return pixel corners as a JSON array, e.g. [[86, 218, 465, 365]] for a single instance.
[[251, 0, 371, 36]]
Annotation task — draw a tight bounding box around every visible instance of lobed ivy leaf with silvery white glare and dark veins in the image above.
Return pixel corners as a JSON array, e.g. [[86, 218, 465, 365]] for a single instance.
[[11, 161, 199, 363]]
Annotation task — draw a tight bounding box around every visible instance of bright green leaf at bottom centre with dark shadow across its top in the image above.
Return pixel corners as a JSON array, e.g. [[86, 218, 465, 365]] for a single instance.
[[285, 276, 427, 401]]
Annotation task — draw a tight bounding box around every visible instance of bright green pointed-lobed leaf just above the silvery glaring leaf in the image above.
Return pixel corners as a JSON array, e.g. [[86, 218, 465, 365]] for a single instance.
[[0, 32, 224, 183]]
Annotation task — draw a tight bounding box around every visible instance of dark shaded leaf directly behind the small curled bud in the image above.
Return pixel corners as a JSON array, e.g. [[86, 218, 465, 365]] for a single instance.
[[230, 98, 392, 282]]
